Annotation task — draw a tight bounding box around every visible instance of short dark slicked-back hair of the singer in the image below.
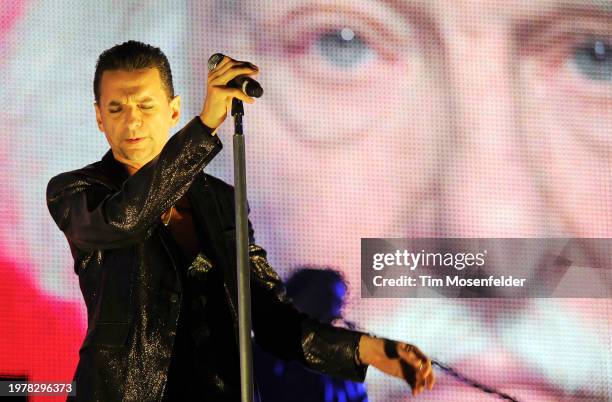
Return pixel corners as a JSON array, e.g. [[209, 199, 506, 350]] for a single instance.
[[94, 40, 174, 103]]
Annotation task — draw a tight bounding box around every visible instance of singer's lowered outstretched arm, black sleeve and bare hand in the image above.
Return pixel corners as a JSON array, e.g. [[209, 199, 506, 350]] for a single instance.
[[250, 244, 435, 395]]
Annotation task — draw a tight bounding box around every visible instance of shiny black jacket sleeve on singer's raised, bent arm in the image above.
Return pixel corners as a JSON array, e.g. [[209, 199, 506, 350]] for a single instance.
[[47, 116, 222, 251]]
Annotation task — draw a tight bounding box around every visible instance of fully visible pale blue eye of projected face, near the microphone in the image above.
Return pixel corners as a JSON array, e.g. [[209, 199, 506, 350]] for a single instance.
[[272, 6, 406, 86]]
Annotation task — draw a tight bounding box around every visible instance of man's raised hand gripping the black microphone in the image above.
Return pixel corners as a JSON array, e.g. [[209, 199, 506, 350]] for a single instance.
[[200, 56, 259, 130]]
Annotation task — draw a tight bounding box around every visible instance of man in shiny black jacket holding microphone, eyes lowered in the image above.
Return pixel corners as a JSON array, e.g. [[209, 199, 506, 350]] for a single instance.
[[47, 41, 434, 401]]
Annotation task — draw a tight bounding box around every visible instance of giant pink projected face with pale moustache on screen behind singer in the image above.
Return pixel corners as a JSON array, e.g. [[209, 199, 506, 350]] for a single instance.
[[194, 0, 612, 400]]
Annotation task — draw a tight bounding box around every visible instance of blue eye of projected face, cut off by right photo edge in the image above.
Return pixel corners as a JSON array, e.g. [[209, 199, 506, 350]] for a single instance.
[[572, 39, 612, 81]]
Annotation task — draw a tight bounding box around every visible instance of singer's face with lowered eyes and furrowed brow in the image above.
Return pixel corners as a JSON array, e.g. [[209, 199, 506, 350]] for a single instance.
[[95, 68, 180, 169]]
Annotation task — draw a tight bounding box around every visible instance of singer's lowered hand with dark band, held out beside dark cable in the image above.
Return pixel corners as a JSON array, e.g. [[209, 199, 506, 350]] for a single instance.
[[358, 335, 435, 395]]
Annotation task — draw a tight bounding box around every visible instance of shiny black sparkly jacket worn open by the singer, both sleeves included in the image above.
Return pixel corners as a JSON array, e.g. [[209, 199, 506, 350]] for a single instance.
[[47, 117, 366, 401]]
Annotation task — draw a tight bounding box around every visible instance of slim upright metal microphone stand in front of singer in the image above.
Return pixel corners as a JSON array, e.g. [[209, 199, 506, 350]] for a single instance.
[[231, 98, 253, 402]]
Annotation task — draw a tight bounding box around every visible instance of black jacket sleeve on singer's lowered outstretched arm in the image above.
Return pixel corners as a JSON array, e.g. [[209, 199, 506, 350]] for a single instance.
[[249, 244, 367, 382]]
